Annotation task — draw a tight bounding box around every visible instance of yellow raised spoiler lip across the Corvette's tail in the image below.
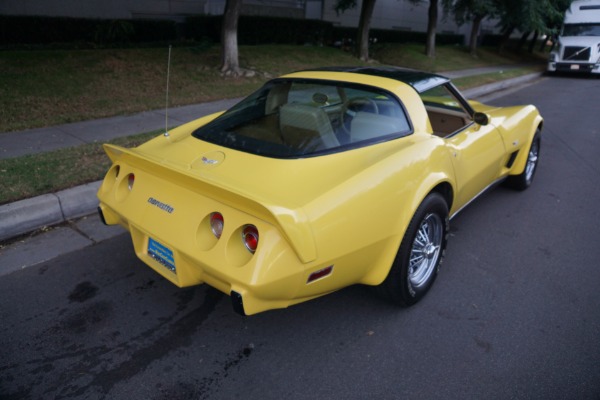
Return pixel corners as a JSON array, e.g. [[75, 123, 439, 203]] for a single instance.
[[104, 144, 317, 264]]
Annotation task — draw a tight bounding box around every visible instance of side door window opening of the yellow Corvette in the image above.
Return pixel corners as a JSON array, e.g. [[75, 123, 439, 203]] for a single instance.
[[420, 85, 472, 137]]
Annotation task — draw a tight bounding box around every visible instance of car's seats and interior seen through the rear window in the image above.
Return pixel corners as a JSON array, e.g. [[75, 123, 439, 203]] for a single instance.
[[236, 82, 410, 153]]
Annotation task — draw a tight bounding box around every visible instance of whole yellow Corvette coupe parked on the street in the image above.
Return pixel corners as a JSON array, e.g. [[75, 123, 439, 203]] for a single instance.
[[98, 67, 542, 315]]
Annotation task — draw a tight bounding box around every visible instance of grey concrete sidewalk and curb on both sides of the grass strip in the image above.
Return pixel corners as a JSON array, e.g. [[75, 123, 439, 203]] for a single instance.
[[0, 67, 540, 242]]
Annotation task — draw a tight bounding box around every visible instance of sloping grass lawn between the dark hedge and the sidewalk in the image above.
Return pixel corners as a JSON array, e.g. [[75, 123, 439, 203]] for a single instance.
[[0, 44, 544, 132]]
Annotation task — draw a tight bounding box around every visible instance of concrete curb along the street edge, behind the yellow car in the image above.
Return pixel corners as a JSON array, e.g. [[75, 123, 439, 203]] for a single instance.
[[0, 73, 541, 241]]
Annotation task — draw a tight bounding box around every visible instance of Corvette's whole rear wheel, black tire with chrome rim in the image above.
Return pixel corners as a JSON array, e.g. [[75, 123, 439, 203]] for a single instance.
[[378, 192, 450, 306]]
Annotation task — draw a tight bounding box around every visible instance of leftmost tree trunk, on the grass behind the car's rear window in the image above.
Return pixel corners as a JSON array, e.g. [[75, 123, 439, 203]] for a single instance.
[[221, 0, 242, 76]]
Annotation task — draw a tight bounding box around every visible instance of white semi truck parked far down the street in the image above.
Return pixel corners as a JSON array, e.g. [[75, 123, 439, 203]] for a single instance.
[[547, 0, 600, 74]]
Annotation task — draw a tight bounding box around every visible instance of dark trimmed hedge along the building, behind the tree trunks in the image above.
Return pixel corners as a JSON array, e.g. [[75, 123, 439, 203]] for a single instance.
[[0, 15, 464, 47]]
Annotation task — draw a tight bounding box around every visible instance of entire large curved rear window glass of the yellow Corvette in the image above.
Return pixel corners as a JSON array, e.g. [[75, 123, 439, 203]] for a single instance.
[[193, 79, 412, 158]]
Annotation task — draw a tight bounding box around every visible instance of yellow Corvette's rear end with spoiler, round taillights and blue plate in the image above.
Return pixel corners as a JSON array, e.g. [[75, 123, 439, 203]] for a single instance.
[[98, 141, 324, 314]]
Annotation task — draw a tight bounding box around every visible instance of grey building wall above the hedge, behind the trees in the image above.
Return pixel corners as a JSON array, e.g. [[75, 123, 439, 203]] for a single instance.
[[0, 0, 495, 36]]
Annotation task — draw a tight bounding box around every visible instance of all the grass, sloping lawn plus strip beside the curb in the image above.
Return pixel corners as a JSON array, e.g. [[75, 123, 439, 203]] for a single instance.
[[0, 44, 539, 204]]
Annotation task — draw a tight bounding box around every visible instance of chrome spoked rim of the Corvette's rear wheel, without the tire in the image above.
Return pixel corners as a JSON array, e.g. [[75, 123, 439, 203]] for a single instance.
[[408, 213, 444, 288]]
